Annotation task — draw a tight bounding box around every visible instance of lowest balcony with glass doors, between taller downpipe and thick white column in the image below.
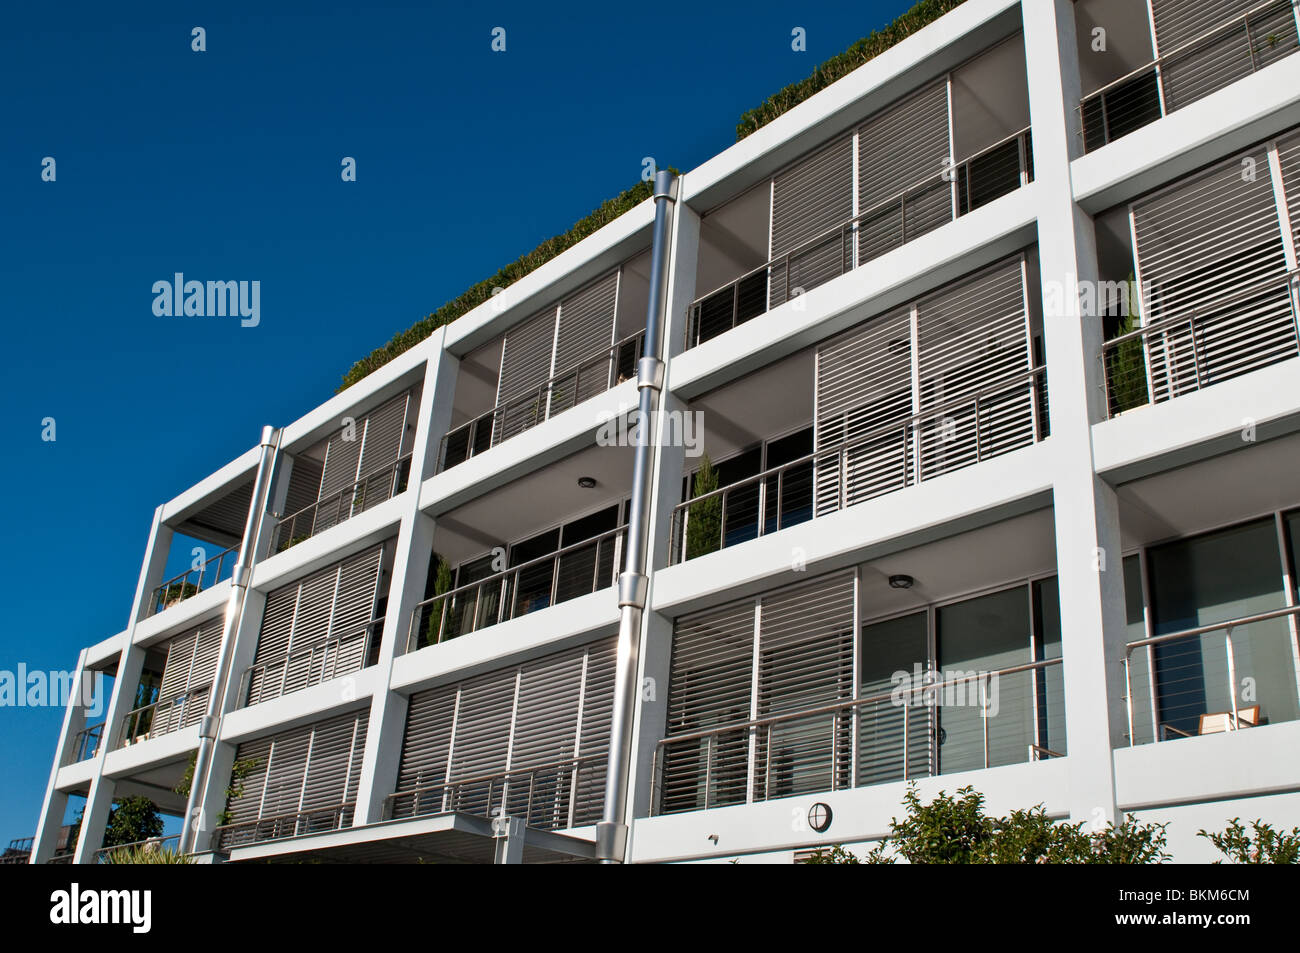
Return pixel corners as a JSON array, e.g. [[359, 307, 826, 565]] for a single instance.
[[651, 510, 1067, 814]]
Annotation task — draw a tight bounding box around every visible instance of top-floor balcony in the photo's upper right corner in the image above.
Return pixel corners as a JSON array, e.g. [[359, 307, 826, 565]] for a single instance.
[[1075, 0, 1300, 152]]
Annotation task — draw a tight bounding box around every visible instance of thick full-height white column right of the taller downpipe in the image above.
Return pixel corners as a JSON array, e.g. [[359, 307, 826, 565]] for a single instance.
[[1022, 0, 1127, 822]]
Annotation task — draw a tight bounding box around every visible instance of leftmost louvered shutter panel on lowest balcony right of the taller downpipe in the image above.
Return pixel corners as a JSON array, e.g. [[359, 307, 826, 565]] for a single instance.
[[660, 599, 754, 814]]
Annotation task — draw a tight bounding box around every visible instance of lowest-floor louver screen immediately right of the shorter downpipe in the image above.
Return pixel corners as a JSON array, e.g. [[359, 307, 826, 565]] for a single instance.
[[221, 711, 369, 849]]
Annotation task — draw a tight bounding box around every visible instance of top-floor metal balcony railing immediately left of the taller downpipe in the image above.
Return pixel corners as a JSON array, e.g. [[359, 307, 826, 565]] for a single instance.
[[438, 332, 645, 472]]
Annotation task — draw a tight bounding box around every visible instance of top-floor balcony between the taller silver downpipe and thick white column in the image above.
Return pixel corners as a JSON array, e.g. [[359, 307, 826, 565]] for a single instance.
[[684, 34, 1034, 348]]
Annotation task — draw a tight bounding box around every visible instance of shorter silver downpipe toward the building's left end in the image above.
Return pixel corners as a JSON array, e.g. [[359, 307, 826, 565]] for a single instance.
[[177, 426, 280, 854]]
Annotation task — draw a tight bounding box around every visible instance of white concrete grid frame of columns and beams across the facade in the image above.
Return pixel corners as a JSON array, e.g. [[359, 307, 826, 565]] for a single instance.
[[33, 0, 1300, 862]]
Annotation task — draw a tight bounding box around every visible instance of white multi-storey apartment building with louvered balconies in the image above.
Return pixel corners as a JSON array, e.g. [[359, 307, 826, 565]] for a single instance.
[[31, 0, 1300, 863]]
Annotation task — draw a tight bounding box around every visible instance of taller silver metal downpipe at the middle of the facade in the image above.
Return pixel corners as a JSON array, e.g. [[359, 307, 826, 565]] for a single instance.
[[595, 172, 677, 863]]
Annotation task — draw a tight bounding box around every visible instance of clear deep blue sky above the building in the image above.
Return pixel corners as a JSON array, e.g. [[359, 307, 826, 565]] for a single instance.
[[0, 0, 913, 848]]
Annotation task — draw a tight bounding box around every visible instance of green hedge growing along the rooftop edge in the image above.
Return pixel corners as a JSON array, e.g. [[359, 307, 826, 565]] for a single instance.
[[335, 0, 965, 393]]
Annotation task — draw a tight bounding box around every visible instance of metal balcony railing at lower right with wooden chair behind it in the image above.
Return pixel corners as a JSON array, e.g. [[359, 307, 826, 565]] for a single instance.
[[1125, 606, 1300, 746]]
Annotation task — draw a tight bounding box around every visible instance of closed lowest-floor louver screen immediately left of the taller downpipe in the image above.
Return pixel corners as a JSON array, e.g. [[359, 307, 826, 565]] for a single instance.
[[393, 640, 614, 829]]
